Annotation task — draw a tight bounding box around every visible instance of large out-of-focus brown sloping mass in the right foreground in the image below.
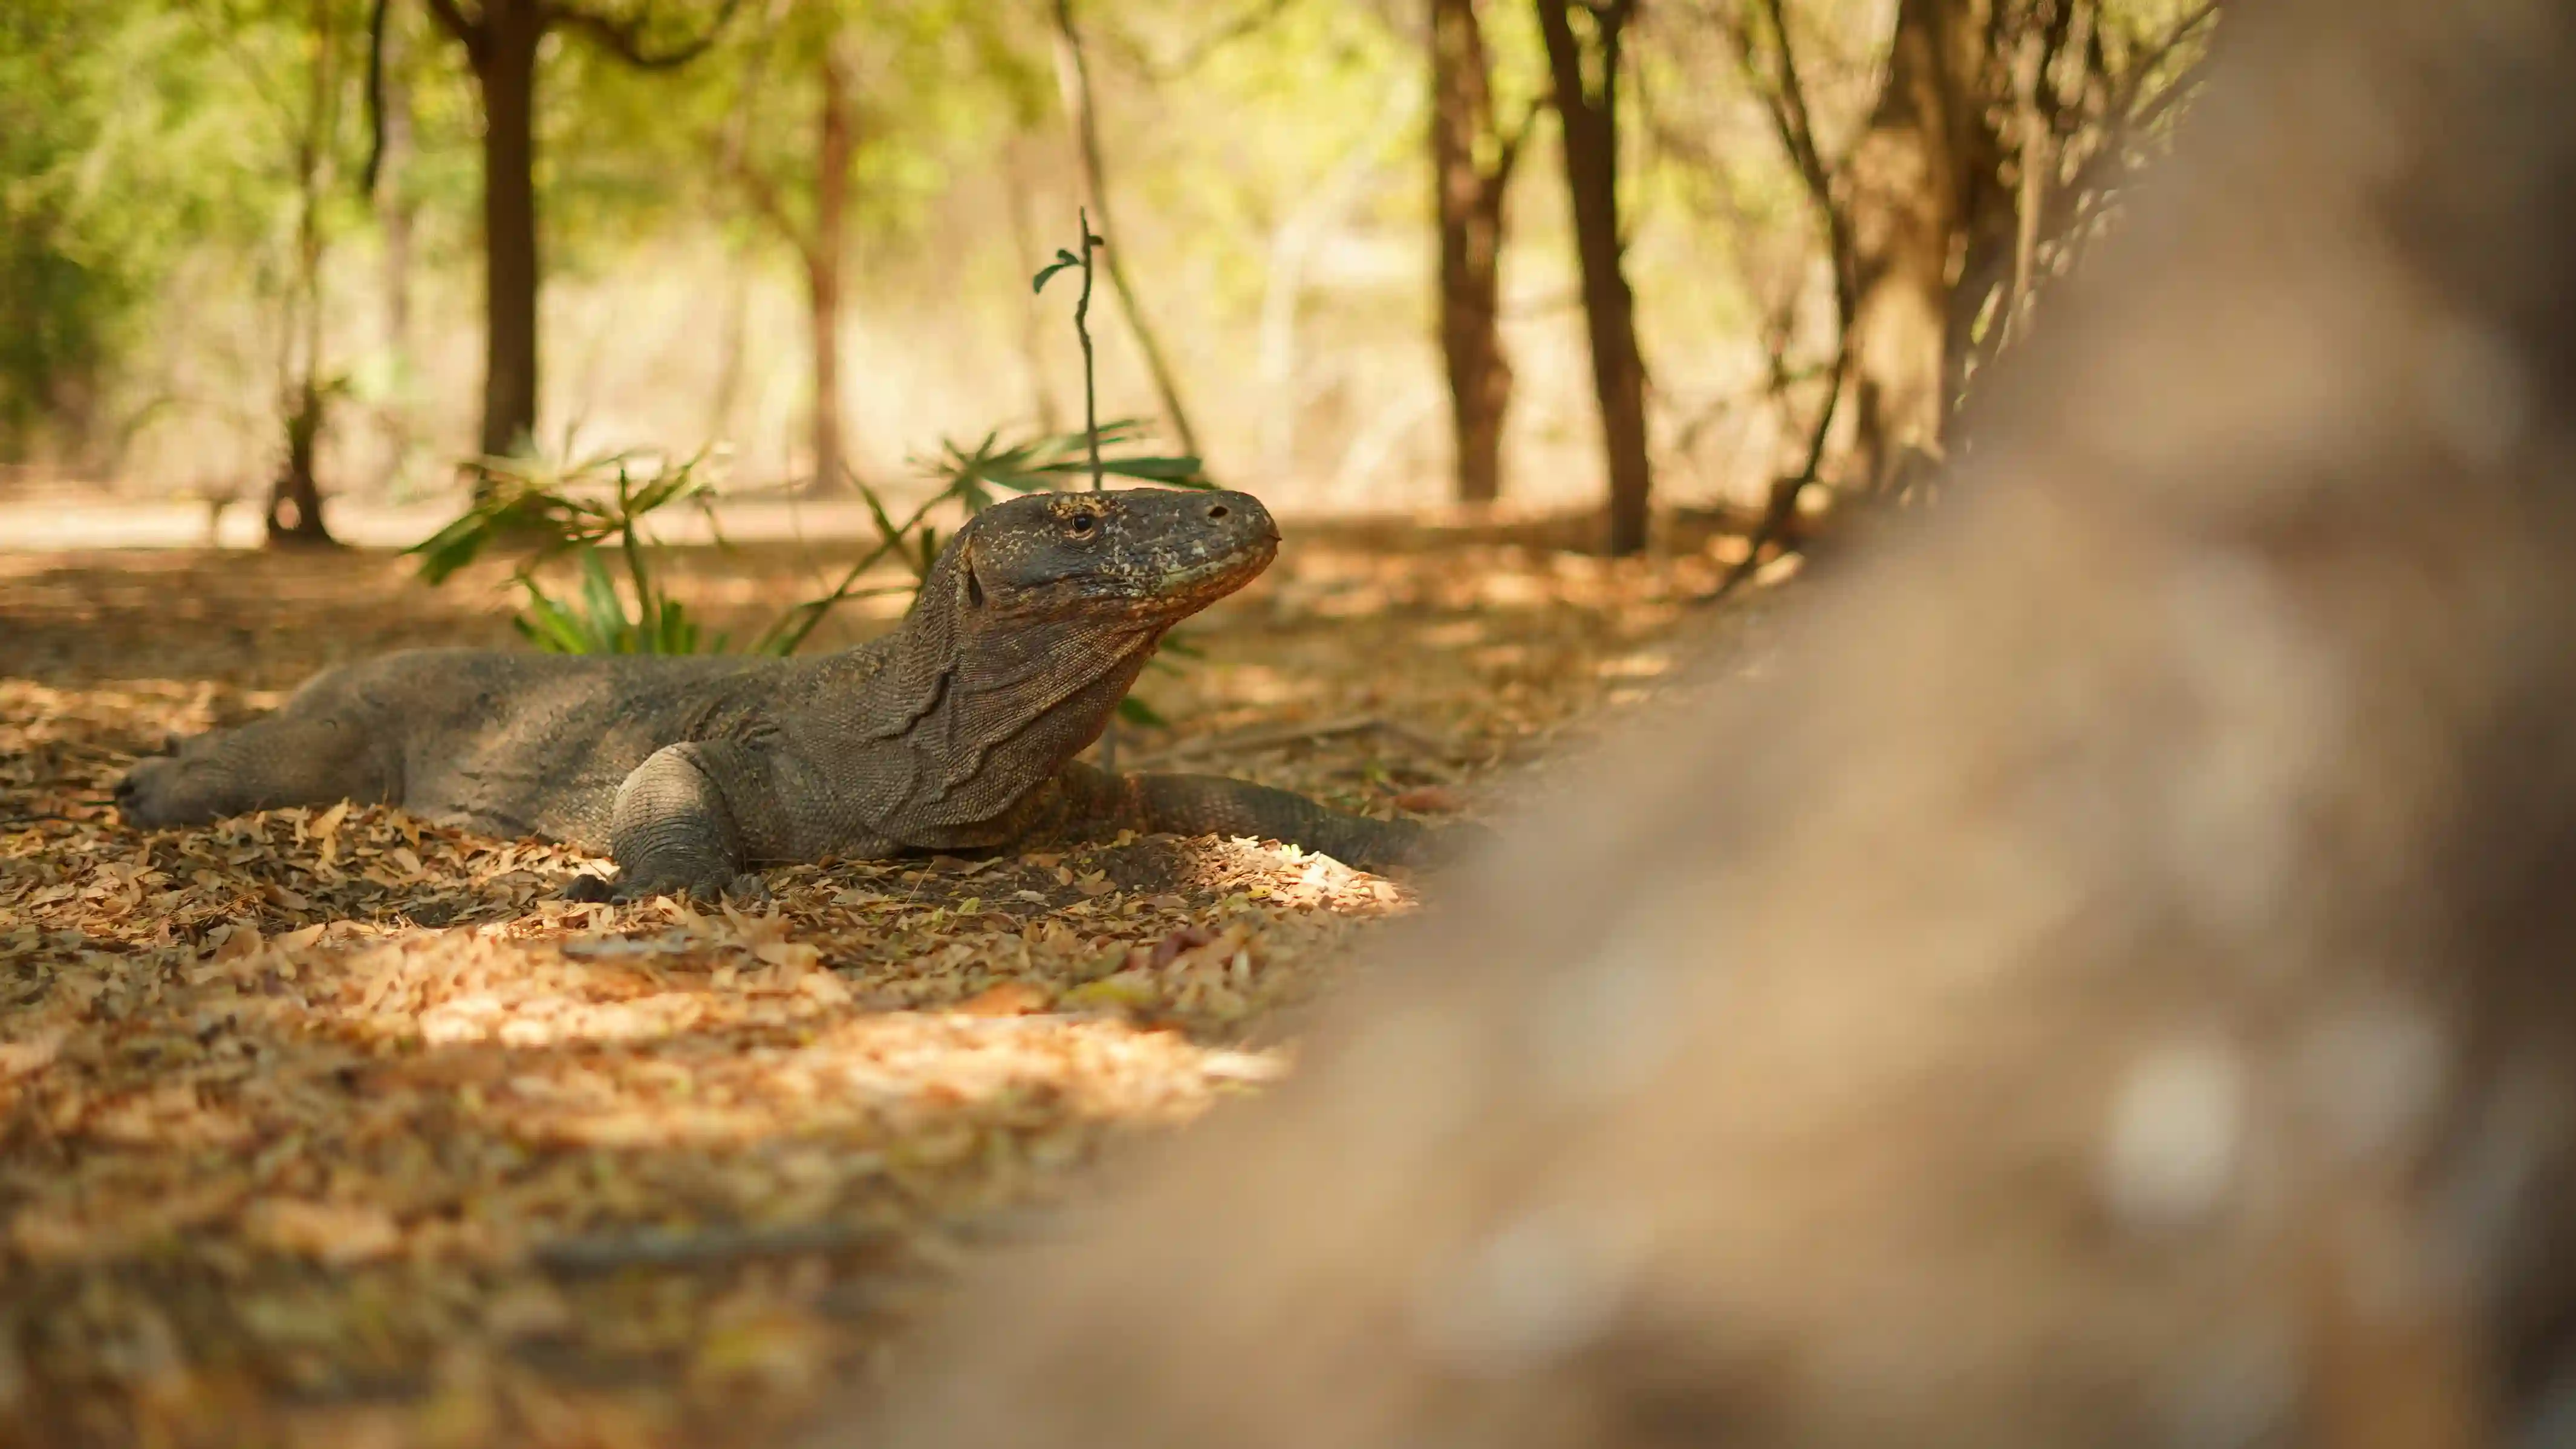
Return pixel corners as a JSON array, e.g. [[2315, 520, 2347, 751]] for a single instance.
[[840, 0, 2576, 1449]]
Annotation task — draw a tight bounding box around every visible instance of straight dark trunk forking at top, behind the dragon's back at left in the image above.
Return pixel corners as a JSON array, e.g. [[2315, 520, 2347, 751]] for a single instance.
[[474, 0, 546, 457]]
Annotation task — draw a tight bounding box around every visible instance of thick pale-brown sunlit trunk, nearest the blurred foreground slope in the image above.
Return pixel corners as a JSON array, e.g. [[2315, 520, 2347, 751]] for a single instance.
[[1842, 0, 2009, 495]]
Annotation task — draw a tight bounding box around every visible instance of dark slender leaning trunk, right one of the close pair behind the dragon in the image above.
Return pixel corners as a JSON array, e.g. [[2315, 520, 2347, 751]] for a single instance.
[[1538, 0, 1654, 557]]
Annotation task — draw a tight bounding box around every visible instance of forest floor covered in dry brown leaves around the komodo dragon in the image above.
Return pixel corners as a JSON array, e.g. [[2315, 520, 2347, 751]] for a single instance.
[[0, 510, 1762, 1449]]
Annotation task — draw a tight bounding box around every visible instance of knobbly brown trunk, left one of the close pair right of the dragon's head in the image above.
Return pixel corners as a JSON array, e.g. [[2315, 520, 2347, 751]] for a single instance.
[[1433, 0, 1517, 503]]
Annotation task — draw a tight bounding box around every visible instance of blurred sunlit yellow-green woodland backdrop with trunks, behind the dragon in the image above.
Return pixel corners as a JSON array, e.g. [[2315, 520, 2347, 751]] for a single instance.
[[0, 0, 2213, 547]]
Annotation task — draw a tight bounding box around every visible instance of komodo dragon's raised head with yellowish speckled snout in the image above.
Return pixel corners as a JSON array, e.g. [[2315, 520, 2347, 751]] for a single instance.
[[925, 487, 1280, 627]]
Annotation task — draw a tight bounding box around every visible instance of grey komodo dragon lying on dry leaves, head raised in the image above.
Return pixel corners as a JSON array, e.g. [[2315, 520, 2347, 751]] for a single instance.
[[116, 490, 1435, 900]]
